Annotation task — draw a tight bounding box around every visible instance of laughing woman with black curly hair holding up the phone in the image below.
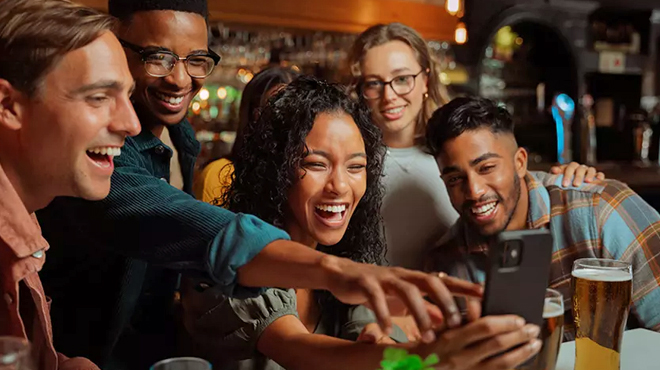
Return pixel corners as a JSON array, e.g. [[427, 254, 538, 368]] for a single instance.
[[182, 77, 539, 370]]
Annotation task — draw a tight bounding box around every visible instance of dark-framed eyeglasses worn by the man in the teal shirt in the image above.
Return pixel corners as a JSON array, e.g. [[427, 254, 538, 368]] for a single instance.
[[119, 39, 220, 78]]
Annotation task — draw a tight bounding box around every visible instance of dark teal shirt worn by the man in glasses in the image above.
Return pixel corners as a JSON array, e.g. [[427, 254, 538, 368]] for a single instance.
[[37, 121, 288, 366]]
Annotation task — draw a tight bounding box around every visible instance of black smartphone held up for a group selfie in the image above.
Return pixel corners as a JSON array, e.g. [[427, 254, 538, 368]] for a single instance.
[[482, 229, 552, 326]]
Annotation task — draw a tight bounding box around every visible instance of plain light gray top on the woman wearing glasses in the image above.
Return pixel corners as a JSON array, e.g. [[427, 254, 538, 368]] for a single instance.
[[382, 147, 458, 270]]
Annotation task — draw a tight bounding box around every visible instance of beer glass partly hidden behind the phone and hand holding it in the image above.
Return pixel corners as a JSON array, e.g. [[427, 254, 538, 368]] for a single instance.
[[517, 289, 564, 370]]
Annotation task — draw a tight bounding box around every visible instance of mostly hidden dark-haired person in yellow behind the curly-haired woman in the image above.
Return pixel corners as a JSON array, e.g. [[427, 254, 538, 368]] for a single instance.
[[193, 66, 299, 204]]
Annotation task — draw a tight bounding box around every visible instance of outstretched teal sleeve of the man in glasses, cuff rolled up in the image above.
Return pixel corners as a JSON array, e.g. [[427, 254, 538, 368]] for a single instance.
[[39, 151, 288, 296]]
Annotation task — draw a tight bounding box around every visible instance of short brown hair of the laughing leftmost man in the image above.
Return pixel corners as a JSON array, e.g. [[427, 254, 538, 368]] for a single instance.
[[0, 0, 116, 96]]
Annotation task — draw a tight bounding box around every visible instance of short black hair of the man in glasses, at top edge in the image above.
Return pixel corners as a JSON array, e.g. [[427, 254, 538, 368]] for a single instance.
[[108, 0, 209, 21]]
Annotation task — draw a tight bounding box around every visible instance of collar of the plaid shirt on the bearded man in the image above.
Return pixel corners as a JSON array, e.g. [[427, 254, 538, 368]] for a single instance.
[[459, 172, 551, 253]]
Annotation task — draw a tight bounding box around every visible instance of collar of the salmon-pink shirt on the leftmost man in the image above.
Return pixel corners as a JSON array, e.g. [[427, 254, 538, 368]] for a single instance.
[[0, 160, 48, 258]]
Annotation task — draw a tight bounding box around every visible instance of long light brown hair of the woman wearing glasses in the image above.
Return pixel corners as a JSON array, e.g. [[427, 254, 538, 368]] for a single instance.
[[348, 23, 449, 137]]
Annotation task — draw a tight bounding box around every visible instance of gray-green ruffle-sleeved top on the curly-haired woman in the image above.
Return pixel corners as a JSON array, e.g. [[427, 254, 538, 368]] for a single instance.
[[182, 283, 407, 370]]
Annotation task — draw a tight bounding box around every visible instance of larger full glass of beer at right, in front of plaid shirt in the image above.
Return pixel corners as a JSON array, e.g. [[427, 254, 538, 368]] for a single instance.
[[572, 258, 632, 370]]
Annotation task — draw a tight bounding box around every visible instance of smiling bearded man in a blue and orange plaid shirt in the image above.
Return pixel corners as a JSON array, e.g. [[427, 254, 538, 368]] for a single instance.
[[427, 98, 660, 340]]
